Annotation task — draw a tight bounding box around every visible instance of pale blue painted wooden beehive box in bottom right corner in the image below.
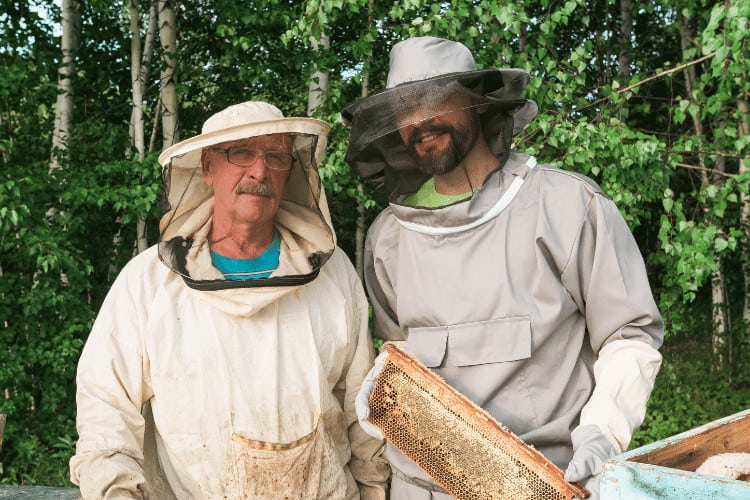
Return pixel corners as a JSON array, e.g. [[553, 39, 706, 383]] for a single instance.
[[600, 410, 750, 500]]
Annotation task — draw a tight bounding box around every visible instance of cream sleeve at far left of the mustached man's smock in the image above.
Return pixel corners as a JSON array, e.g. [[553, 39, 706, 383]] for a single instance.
[[70, 260, 151, 499]]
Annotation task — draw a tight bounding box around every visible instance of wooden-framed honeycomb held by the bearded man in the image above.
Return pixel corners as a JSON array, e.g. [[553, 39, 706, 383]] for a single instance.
[[369, 344, 588, 500]]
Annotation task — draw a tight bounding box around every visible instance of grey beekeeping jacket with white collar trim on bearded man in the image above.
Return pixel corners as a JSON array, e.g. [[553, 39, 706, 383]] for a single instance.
[[358, 158, 663, 474]]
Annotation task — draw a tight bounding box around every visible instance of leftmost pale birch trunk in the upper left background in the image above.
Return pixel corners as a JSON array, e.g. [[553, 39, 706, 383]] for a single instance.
[[49, 0, 81, 175]]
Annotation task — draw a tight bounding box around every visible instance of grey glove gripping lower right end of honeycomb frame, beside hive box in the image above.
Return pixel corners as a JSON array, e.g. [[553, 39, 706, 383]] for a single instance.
[[565, 425, 617, 500]]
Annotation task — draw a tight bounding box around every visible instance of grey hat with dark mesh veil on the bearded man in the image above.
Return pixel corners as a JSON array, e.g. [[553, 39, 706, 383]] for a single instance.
[[341, 37, 537, 182]]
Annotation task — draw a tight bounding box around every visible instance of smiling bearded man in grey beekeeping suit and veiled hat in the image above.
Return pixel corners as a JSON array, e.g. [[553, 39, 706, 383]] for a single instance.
[[342, 37, 663, 500]]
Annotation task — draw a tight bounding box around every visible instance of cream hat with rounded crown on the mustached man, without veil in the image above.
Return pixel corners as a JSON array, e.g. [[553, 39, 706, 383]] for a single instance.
[[159, 101, 330, 168]]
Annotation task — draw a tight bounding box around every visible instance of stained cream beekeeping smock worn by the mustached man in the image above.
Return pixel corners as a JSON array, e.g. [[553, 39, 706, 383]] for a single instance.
[[71, 244, 388, 499]]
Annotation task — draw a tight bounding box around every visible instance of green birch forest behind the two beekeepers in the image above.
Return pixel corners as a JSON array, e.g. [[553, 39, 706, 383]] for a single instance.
[[0, 0, 750, 485]]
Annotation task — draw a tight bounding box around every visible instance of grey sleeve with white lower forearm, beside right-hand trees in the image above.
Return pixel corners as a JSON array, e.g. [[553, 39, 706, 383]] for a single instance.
[[563, 196, 664, 451]]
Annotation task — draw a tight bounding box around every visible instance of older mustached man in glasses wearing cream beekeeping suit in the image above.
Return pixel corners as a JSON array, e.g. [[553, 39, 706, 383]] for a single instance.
[[70, 102, 389, 499]]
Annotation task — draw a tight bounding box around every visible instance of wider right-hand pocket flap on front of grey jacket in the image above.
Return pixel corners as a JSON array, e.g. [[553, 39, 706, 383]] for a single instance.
[[448, 316, 531, 366]]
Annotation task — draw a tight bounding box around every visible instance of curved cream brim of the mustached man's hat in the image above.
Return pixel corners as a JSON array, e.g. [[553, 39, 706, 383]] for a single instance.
[[158, 118, 331, 168]]
